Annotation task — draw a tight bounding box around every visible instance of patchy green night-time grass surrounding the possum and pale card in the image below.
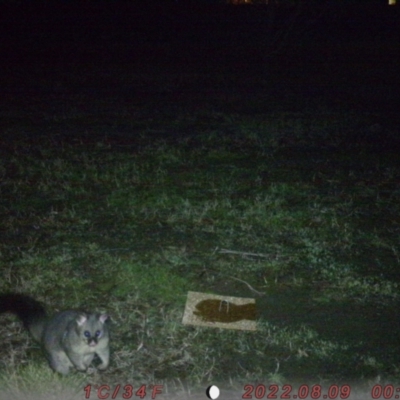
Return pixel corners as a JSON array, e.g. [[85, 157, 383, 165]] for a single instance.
[[0, 95, 400, 396]]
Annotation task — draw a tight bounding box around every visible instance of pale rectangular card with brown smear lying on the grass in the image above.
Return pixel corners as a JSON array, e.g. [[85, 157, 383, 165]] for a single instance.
[[182, 292, 257, 331]]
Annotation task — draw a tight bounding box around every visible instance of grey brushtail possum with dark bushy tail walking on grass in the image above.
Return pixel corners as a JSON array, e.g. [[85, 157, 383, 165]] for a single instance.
[[0, 293, 110, 375]]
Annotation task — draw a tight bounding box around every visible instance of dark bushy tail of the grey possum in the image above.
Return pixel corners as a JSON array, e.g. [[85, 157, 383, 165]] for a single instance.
[[0, 293, 47, 342]]
